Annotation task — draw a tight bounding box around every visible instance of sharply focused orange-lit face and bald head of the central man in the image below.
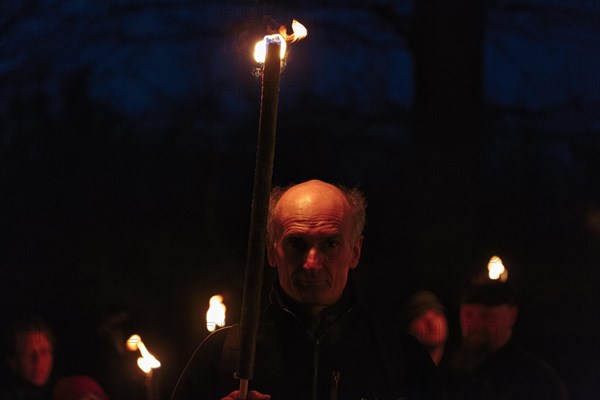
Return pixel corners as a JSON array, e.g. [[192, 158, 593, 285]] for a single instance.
[[268, 181, 362, 311]]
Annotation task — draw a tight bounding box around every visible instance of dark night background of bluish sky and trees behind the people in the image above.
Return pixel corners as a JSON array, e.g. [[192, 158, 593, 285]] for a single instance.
[[0, 0, 600, 400]]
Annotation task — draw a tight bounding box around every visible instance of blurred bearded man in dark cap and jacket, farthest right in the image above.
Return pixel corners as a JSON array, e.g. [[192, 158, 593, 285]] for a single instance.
[[443, 281, 568, 400]]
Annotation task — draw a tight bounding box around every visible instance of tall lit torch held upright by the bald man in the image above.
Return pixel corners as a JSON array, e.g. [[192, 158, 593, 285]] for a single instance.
[[236, 20, 308, 400]]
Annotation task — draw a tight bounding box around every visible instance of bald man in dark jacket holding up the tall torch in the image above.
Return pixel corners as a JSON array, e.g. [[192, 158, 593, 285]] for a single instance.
[[173, 180, 440, 400]]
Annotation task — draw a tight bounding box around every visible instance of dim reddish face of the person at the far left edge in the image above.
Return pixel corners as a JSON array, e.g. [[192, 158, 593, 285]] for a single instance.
[[10, 332, 53, 386]]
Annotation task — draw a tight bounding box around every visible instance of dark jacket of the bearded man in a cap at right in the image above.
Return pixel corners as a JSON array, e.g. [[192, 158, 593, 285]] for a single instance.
[[443, 341, 569, 400]]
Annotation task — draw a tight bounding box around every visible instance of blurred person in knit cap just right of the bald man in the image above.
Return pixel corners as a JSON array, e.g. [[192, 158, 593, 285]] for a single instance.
[[402, 290, 448, 366]]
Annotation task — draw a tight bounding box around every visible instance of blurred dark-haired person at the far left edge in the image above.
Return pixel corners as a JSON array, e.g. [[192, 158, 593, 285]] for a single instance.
[[0, 317, 54, 400]]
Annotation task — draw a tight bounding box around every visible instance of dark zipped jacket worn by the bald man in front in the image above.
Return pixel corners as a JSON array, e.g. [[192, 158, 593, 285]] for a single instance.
[[173, 288, 440, 400]]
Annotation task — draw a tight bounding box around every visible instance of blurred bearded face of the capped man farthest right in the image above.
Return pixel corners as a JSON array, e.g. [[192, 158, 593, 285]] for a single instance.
[[460, 303, 517, 351]]
